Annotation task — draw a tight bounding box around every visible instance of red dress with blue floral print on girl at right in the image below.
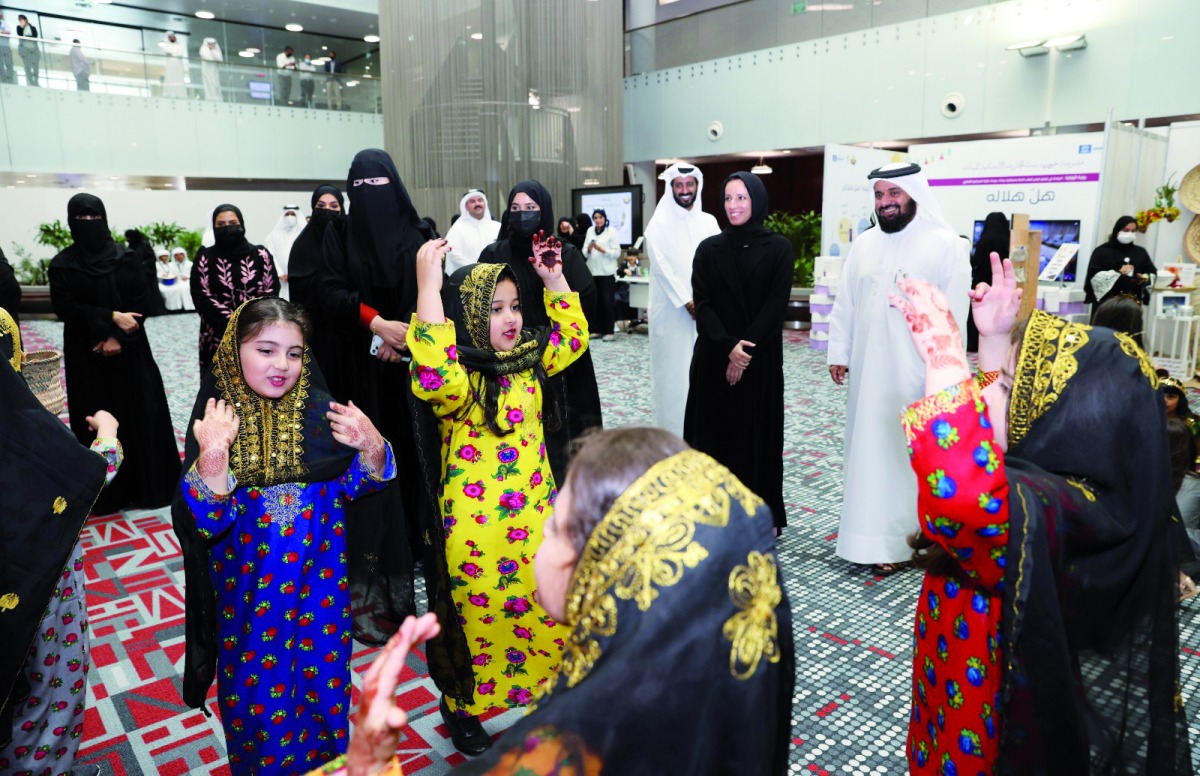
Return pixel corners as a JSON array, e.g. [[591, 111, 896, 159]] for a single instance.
[[904, 380, 1008, 776]]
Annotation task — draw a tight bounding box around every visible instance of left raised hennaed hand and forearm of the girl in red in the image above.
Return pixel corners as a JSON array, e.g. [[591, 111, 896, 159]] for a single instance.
[[888, 278, 971, 393]]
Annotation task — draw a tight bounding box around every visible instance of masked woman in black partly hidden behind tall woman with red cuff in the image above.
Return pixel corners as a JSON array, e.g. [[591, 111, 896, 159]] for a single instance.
[[288, 185, 346, 396]]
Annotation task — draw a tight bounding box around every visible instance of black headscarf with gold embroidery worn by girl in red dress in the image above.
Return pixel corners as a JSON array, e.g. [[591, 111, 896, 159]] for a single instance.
[[996, 311, 1192, 774]]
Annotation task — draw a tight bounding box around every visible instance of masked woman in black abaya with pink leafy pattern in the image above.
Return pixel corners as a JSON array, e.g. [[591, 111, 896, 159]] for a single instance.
[[191, 204, 280, 378]]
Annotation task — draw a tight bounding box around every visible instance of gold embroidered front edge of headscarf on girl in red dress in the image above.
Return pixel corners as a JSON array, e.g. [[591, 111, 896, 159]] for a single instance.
[[1008, 309, 1092, 446]]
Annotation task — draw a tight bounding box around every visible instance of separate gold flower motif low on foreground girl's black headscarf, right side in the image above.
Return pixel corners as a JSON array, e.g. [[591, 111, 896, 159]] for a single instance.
[[721, 551, 784, 680]]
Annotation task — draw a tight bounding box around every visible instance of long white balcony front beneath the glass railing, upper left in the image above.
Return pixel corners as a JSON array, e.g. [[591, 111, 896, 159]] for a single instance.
[[0, 85, 383, 180]]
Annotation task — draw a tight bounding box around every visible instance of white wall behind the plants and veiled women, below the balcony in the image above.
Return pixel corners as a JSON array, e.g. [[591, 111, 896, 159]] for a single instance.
[[0, 186, 312, 261]]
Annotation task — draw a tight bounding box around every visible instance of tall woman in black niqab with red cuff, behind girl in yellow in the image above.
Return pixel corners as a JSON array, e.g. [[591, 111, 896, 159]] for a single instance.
[[317, 149, 433, 563]]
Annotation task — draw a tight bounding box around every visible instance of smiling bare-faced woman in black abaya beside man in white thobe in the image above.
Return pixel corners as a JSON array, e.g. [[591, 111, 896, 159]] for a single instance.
[[683, 173, 793, 527]]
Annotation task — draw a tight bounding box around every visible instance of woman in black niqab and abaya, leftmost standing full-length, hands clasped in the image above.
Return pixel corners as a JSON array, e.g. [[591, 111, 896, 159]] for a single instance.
[[49, 194, 180, 515]]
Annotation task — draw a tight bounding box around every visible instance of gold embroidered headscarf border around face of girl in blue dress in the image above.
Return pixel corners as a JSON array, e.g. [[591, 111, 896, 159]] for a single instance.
[[212, 300, 310, 487]]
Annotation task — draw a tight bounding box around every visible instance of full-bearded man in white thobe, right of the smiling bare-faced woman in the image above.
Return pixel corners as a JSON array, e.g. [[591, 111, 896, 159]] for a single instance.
[[828, 163, 971, 573]]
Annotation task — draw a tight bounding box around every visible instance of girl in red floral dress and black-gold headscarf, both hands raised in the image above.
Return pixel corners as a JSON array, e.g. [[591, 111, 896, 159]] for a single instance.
[[892, 253, 1194, 775]]
